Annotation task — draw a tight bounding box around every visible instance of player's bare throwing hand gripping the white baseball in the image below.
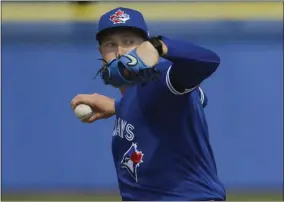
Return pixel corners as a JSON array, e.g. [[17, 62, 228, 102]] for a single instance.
[[71, 93, 115, 123]]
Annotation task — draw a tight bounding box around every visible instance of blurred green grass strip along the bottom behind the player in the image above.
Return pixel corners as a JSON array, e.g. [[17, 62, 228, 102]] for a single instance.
[[2, 193, 283, 201]]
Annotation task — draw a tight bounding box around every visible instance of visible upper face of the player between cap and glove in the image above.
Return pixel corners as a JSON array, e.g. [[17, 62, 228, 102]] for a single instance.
[[100, 30, 144, 61]]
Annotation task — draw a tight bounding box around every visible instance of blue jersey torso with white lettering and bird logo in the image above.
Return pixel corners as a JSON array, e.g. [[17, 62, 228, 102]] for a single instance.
[[112, 60, 225, 201]]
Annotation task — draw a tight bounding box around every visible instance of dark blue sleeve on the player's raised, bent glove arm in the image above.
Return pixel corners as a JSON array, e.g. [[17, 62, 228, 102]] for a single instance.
[[161, 36, 220, 90]]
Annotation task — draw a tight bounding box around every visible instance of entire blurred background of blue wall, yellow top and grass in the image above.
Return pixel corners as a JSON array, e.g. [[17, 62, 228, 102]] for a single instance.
[[1, 2, 283, 201]]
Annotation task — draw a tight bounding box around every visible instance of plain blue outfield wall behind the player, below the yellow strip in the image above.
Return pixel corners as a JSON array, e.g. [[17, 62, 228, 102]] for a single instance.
[[2, 22, 283, 190]]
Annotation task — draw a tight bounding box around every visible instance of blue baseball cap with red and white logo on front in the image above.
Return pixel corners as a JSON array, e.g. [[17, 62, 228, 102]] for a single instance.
[[96, 7, 149, 40]]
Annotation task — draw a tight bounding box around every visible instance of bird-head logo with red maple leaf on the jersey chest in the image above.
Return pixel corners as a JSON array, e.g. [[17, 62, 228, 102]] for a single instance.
[[121, 143, 144, 182]]
